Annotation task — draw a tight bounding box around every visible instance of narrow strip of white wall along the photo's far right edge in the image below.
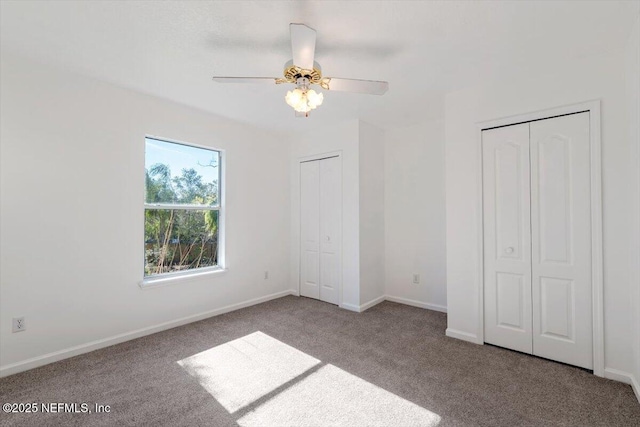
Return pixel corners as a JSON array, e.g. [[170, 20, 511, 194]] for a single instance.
[[625, 16, 640, 400]]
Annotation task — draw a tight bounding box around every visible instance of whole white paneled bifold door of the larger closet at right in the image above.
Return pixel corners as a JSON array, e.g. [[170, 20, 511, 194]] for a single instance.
[[482, 112, 593, 369]]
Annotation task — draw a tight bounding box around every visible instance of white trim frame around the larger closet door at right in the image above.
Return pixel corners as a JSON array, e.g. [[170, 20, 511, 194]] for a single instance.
[[476, 99, 605, 377]]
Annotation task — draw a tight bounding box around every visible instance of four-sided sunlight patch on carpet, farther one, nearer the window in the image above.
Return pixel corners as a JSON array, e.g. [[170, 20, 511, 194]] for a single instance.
[[177, 332, 320, 413]]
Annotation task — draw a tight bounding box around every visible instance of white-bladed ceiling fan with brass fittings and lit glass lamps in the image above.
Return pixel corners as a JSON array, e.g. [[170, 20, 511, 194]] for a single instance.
[[213, 24, 389, 117]]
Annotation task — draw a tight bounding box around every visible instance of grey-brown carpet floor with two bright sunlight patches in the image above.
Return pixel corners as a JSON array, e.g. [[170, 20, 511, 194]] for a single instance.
[[0, 296, 640, 427]]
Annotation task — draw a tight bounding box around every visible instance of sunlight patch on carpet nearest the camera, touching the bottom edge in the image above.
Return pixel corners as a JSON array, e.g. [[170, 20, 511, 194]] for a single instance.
[[237, 365, 441, 427]]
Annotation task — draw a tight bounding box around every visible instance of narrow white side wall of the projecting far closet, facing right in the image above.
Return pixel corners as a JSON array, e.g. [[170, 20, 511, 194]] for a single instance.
[[359, 121, 385, 307]]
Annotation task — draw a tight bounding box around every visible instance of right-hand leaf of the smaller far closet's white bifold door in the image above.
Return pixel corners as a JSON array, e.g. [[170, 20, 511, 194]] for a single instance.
[[318, 157, 342, 304]]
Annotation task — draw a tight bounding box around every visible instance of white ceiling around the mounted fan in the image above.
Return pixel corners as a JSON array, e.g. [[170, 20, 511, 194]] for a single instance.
[[0, 0, 640, 130]]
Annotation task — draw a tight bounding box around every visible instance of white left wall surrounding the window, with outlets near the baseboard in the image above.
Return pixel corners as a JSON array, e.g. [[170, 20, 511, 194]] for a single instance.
[[0, 52, 290, 374]]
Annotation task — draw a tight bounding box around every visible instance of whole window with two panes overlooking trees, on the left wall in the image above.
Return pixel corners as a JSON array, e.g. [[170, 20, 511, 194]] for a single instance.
[[144, 137, 222, 278]]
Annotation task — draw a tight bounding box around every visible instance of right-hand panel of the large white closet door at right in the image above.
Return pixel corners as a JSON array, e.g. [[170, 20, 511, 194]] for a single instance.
[[531, 113, 593, 369]]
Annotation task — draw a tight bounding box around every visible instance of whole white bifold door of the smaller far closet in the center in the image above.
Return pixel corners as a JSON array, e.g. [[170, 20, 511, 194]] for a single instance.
[[300, 157, 342, 304]]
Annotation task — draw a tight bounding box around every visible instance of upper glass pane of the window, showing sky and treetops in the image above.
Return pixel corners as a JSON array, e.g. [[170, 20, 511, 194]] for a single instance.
[[145, 138, 220, 206]]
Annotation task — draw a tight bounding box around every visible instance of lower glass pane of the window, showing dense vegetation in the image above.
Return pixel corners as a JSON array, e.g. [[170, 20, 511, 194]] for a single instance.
[[144, 209, 218, 276]]
